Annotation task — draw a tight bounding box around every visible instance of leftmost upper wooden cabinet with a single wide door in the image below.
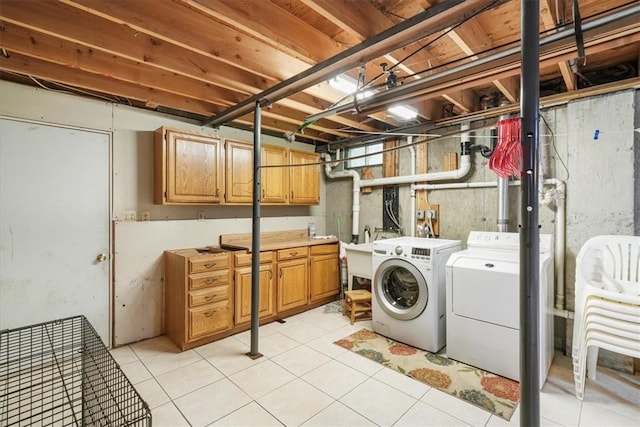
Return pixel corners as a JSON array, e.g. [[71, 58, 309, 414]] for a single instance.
[[154, 127, 224, 204]]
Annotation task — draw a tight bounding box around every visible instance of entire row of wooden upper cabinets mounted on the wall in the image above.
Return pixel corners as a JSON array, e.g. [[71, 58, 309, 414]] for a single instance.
[[154, 127, 320, 205]]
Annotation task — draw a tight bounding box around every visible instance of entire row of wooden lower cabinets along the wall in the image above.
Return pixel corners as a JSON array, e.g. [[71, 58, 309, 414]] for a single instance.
[[164, 234, 340, 350]]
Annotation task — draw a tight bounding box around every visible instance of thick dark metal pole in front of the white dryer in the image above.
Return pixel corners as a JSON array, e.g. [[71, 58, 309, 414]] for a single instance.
[[520, 0, 540, 427]]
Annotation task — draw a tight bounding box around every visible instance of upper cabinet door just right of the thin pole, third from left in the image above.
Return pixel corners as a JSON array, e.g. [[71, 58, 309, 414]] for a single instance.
[[260, 145, 289, 204]]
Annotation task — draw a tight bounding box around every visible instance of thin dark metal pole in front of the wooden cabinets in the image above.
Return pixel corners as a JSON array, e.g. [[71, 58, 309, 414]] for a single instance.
[[247, 100, 262, 359]]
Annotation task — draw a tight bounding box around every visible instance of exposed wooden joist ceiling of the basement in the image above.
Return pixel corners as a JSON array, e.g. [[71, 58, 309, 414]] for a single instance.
[[0, 0, 640, 146]]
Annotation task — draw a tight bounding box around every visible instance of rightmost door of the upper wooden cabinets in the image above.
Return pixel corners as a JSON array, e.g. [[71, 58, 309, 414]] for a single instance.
[[289, 150, 320, 205]]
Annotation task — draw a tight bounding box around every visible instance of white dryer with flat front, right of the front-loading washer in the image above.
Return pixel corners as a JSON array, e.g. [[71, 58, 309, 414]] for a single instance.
[[446, 231, 554, 387]]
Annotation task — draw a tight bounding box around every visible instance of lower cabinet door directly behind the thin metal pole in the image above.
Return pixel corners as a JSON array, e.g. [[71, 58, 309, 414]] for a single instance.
[[235, 264, 275, 325]]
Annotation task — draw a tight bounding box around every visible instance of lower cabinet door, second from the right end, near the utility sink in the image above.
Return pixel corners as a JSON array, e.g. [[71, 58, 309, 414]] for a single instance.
[[278, 258, 309, 313]]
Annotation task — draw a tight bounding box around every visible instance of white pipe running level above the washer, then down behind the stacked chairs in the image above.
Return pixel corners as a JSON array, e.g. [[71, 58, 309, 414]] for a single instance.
[[411, 178, 571, 318]]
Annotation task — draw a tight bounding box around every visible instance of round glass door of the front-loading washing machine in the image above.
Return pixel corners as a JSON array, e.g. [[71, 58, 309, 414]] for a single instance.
[[373, 258, 429, 320]]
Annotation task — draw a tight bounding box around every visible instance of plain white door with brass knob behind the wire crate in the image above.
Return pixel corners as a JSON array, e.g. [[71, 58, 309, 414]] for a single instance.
[[0, 119, 110, 345]]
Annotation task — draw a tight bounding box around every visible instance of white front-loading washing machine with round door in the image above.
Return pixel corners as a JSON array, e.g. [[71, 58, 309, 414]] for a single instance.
[[371, 237, 462, 353]]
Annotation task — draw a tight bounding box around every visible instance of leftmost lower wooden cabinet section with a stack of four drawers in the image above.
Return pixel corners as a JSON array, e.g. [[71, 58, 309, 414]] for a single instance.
[[164, 249, 233, 350]]
